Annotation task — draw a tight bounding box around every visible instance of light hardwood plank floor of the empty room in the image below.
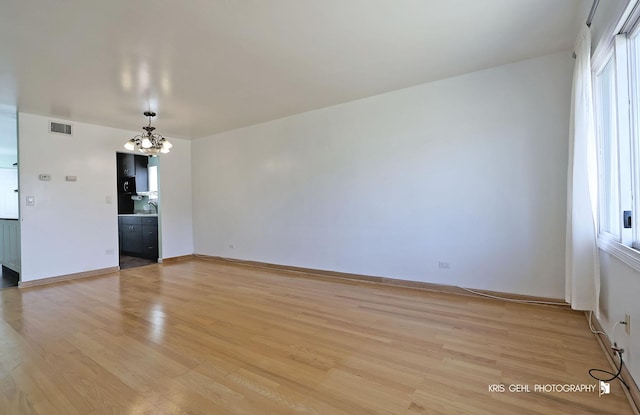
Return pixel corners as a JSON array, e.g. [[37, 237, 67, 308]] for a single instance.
[[0, 259, 633, 415]]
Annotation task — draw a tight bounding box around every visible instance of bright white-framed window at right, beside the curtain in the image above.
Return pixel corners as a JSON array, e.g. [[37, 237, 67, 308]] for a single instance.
[[592, 9, 640, 270]]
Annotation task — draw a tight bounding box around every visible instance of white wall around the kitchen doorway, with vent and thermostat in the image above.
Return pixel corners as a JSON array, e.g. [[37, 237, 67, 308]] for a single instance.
[[19, 113, 193, 281]]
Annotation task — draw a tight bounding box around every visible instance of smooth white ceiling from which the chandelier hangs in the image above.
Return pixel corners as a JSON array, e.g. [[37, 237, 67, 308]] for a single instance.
[[0, 0, 587, 138]]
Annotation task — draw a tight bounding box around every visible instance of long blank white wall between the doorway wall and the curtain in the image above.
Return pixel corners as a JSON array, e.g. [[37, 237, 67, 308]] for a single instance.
[[192, 52, 573, 298]]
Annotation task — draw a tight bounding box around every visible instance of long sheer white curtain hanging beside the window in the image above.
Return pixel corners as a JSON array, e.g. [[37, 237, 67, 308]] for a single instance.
[[565, 25, 600, 313]]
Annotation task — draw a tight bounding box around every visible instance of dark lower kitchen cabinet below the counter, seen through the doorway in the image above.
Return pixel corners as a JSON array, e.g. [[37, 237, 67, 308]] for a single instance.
[[118, 216, 158, 260]]
